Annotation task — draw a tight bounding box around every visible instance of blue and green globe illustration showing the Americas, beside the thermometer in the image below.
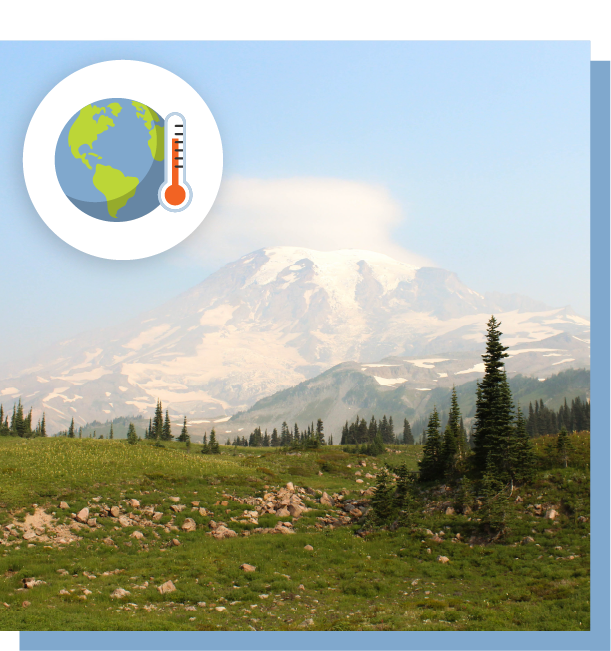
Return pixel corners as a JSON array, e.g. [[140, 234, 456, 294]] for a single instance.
[[55, 98, 164, 222]]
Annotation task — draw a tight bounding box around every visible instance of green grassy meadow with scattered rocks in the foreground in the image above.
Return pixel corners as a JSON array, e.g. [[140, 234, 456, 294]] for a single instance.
[[0, 433, 589, 630]]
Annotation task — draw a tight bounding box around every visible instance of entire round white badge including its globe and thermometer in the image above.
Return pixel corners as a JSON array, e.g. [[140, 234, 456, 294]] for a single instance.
[[23, 61, 223, 260]]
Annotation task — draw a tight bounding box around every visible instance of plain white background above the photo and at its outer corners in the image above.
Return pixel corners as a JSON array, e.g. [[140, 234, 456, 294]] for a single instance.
[[0, 0, 611, 651]]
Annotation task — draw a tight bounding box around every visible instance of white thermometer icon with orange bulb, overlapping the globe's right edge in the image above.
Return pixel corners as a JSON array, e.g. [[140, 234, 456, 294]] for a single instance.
[[159, 113, 193, 212]]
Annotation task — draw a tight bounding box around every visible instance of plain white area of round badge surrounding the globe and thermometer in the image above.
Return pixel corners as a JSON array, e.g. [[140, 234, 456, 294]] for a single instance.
[[23, 61, 223, 260]]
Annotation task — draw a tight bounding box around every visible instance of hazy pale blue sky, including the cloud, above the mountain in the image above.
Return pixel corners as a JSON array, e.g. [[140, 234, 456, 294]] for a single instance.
[[0, 42, 589, 366]]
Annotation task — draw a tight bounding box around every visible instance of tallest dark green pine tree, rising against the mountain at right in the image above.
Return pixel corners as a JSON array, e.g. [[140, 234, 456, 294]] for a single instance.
[[474, 316, 515, 479]]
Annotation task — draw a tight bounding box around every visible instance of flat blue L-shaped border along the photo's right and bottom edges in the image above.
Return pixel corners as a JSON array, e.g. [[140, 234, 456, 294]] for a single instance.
[[20, 61, 611, 651]]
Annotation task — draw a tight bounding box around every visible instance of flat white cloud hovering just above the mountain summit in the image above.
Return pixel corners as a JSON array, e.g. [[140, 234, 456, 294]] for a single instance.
[[175, 177, 434, 265]]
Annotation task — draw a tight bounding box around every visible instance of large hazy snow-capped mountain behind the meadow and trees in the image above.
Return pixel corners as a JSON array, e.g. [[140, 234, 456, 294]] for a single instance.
[[0, 247, 589, 428]]
